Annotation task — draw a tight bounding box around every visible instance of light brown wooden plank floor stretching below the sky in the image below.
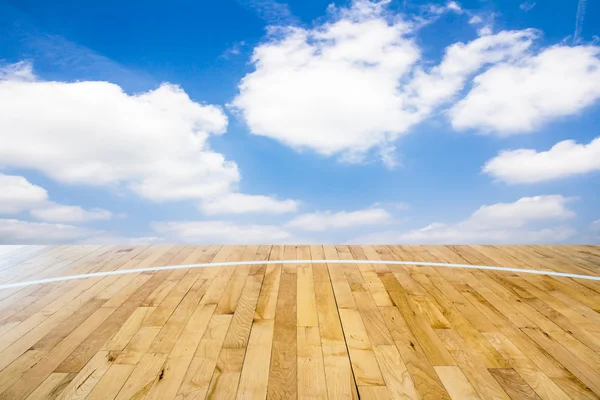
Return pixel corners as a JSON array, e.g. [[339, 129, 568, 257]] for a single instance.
[[0, 245, 600, 400]]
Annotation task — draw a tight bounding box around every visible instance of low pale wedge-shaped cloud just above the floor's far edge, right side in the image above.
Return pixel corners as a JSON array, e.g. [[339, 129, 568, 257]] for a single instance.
[[354, 195, 576, 244]]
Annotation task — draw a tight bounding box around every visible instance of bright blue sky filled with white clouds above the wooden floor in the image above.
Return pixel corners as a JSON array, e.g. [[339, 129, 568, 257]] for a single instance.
[[0, 0, 600, 243]]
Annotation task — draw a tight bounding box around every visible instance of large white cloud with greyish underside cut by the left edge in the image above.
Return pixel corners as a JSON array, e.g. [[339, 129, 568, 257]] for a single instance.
[[0, 64, 234, 200]]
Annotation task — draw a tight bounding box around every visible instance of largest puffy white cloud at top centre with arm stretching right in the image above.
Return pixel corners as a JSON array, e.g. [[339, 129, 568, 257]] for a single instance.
[[231, 0, 536, 166]]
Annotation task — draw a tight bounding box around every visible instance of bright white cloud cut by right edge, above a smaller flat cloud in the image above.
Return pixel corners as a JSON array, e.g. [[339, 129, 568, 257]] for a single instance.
[[450, 46, 600, 135]]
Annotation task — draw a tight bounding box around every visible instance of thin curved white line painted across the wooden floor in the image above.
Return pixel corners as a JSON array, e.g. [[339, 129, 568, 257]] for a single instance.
[[0, 260, 600, 290]]
